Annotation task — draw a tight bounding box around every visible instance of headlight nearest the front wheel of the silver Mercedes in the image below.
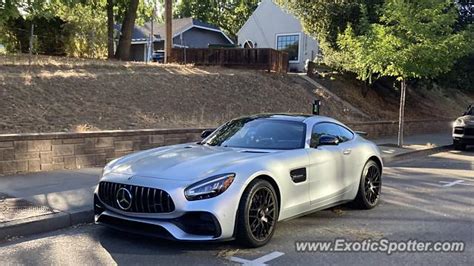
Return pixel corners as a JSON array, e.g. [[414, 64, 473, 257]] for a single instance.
[[184, 174, 235, 200]]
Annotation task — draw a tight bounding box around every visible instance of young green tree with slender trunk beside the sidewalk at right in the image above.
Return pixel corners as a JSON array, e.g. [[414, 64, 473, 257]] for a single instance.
[[337, 0, 473, 146]]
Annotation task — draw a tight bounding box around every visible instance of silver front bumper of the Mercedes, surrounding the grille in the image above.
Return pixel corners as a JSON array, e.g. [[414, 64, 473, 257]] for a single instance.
[[94, 172, 240, 241]]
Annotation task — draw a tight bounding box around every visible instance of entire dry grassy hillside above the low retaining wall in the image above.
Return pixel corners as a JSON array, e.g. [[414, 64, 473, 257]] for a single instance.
[[0, 56, 472, 133]]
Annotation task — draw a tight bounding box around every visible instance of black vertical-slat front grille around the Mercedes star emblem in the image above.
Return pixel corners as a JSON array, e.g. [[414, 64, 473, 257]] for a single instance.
[[99, 182, 175, 213]]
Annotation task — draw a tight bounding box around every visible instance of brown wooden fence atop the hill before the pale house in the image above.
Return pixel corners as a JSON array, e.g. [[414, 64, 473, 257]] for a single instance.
[[169, 48, 288, 73]]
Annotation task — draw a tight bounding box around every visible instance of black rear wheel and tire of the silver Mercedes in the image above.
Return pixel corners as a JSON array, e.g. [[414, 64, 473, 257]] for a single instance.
[[353, 160, 382, 210]]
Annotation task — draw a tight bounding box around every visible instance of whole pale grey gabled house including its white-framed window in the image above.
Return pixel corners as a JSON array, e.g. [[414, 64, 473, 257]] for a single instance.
[[237, 0, 319, 71]]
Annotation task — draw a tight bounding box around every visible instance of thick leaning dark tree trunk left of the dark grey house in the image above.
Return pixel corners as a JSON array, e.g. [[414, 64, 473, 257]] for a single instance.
[[115, 0, 139, 61]]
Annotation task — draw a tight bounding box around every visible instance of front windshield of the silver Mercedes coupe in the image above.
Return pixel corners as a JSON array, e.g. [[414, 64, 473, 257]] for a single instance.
[[202, 118, 306, 150]]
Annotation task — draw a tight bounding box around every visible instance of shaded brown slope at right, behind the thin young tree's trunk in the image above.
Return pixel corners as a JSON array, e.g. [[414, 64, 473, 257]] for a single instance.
[[315, 72, 474, 120]]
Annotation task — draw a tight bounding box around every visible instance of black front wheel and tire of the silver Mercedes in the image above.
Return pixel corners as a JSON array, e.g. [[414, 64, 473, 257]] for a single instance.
[[236, 179, 279, 248]]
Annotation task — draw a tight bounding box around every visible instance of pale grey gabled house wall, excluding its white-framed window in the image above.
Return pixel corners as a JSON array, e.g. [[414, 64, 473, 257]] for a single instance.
[[237, 0, 319, 71]]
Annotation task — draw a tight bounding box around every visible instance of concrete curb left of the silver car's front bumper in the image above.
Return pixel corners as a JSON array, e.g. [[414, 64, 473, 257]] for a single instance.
[[0, 209, 94, 241]]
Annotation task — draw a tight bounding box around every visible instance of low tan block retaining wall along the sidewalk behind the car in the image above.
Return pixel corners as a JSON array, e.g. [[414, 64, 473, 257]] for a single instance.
[[0, 120, 452, 174]]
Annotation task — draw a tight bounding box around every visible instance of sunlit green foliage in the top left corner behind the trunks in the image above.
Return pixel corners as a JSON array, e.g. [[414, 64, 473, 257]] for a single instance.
[[0, 0, 156, 58]]
